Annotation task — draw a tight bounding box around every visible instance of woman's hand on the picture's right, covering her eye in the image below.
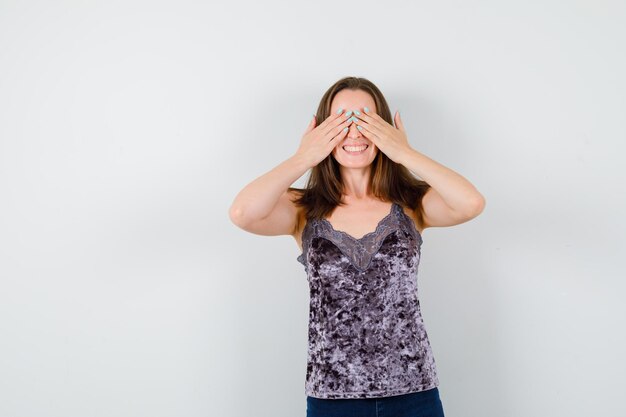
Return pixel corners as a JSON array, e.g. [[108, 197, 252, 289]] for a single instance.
[[354, 110, 413, 163]]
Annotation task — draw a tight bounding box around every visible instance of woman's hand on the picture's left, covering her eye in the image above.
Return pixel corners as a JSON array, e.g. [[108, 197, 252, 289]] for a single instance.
[[296, 109, 352, 168]]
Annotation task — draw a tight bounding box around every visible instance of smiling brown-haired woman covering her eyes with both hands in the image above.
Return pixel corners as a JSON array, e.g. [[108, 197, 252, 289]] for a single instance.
[[229, 77, 485, 417]]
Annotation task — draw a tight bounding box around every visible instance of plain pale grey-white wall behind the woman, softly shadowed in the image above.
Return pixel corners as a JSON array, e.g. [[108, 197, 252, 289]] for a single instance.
[[0, 0, 626, 417]]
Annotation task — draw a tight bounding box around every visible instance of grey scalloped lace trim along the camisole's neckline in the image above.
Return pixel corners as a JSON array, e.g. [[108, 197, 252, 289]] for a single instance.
[[297, 202, 422, 272]]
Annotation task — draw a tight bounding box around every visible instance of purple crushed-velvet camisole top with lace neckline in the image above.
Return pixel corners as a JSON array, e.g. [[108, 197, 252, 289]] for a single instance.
[[297, 202, 439, 399]]
